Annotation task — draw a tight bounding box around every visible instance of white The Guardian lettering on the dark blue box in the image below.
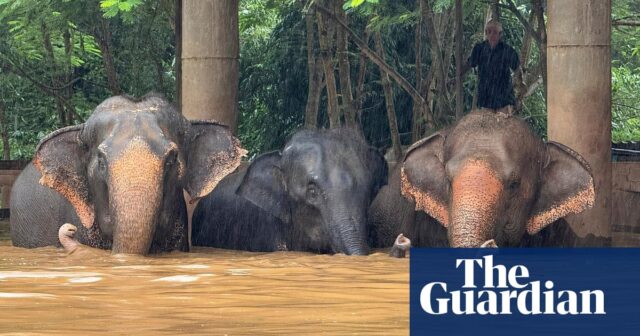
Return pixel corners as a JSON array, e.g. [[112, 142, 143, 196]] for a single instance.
[[420, 255, 606, 315]]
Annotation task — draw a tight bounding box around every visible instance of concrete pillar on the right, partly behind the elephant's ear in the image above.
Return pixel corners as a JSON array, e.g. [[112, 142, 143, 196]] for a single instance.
[[547, 0, 612, 242]]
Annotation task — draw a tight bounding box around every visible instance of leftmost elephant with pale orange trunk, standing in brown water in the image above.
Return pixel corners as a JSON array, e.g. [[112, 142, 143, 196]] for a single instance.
[[10, 93, 246, 255]]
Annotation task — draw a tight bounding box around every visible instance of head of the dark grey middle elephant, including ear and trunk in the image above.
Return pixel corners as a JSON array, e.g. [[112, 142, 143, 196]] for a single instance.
[[237, 130, 387, 255]]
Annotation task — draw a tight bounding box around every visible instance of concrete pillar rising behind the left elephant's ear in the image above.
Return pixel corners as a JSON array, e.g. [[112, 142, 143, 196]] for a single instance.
[[180, 0, 240, 133]]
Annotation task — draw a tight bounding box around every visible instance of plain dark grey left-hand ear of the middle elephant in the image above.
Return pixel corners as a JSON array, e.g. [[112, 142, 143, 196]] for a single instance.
[[236, 151, 291, 223]]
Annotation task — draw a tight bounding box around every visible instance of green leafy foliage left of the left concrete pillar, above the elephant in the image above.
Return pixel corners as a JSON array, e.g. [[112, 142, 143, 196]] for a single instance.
[[0, 0, 175, 159]]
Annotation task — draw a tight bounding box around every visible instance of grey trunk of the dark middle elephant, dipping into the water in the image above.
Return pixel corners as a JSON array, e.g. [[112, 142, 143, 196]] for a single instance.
[[328, 206, 369, 255]]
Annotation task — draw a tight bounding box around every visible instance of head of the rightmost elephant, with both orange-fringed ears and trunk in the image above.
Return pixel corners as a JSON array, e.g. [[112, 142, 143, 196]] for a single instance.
[[401, 112, 595, 247]]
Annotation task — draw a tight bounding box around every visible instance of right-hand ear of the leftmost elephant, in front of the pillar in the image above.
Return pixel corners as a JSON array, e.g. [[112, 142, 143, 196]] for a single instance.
[[183, 120, 247, 202]]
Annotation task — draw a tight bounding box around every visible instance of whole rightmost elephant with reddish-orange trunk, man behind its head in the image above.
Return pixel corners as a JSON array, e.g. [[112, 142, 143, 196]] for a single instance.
[[369, 111, 595, 247]]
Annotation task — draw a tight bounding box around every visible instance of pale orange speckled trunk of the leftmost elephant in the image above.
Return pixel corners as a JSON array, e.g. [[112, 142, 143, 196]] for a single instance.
[[109, 141, 164, 254]]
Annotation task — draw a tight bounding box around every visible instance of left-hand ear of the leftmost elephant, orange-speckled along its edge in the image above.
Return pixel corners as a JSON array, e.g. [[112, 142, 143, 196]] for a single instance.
[[33, 125, 95, 228]]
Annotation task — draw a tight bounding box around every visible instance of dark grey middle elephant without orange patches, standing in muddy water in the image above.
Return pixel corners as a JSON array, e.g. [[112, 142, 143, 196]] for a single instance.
[[192, 129, 387, 255]]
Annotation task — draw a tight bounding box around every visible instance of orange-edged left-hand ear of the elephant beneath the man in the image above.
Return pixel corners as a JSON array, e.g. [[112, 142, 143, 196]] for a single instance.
[[400, 132, 449, 227]]
